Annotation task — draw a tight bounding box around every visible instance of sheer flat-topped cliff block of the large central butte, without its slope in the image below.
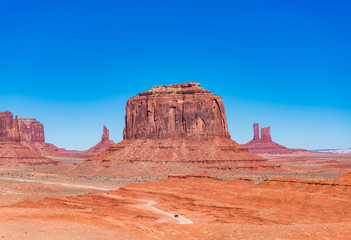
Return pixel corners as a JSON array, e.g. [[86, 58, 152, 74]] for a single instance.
[[123, 82, 230, 139]]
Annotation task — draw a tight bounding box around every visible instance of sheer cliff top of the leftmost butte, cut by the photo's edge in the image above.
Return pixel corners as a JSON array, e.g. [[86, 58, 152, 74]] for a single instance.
[[0, 111, 20, 142]]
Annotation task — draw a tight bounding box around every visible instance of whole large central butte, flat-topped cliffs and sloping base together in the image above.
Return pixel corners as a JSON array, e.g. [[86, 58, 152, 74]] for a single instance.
[[80, 82, 278, 172]]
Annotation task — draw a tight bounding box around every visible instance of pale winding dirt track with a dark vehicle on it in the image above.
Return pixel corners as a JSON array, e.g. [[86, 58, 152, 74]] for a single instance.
[[104, 193, 194, 224]]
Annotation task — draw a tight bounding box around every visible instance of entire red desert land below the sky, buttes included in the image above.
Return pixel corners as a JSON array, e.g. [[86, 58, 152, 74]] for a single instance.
[[0, 83, 351, 240]]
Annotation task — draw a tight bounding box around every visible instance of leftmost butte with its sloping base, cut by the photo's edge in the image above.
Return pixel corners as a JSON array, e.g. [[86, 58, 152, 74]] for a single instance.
[[0, 111, 58, 167]]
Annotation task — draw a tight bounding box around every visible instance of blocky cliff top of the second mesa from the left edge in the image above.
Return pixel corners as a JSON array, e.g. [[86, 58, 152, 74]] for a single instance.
[[18, 118, 45, 143]]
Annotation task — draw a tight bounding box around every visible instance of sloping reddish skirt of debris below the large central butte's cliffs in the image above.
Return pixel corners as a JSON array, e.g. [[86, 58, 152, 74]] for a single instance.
[[82, 137, 279, 176]]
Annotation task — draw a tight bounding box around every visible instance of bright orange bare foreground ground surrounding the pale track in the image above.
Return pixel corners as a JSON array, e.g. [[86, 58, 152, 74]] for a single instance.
[[0, 174, 351, 239]]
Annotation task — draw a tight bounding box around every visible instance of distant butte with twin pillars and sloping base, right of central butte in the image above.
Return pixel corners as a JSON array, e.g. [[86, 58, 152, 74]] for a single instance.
[[243, 123, 307, 154]]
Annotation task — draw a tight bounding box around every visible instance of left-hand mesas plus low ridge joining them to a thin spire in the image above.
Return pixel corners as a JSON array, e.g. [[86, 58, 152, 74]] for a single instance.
[[0, 111, 115, 167]]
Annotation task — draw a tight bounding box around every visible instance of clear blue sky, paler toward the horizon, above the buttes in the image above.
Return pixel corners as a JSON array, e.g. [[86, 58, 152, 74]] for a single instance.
[[0, 0, 351, 149]]
